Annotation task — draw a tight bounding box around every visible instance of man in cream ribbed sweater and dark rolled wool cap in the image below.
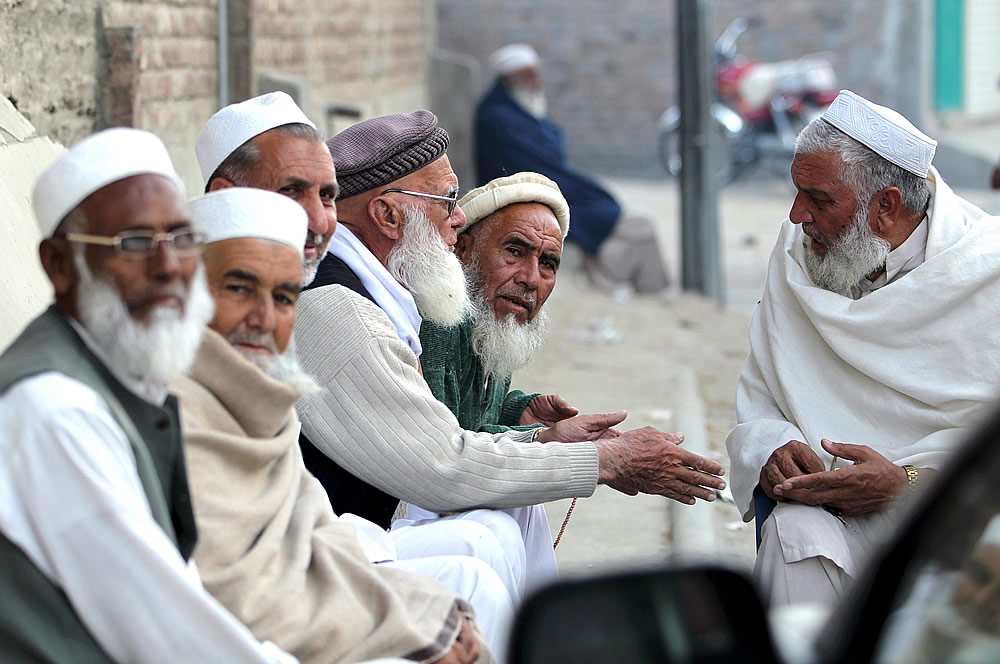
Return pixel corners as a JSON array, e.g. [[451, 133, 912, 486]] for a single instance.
[[296, 111, 725, 586]]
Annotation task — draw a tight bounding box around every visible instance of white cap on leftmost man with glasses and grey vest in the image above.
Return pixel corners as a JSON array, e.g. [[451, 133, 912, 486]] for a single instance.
[[31, 127, 184, 237]]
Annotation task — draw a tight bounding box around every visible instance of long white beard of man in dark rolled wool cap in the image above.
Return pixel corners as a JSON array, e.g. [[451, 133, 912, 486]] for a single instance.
[[386, 206, 469, 327]]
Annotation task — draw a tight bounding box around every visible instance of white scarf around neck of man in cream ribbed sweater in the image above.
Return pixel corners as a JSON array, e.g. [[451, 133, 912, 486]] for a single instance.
[[328, 224, 422, 357]]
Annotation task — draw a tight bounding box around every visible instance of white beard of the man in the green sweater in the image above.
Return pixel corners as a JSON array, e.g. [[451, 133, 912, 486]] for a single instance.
[[465, 258, 548, 380]]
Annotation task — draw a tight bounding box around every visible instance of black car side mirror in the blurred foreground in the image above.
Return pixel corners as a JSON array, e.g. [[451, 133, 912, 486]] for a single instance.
[[509, 566, 777, 664]]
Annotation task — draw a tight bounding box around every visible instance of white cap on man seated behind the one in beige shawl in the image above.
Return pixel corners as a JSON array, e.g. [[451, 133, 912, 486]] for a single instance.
[[194, 92, 316, 182]]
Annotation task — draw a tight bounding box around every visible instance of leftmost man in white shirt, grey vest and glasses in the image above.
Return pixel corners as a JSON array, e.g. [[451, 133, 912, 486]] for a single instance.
[[0, 129, 296, 663]]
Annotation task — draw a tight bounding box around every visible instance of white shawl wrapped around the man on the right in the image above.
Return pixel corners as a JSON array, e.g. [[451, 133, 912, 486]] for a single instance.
[[726, 168, 1000, 521]]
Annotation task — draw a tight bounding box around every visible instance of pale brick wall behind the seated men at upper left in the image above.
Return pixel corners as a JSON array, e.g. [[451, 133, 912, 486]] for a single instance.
[[0, 0, 434, 193]]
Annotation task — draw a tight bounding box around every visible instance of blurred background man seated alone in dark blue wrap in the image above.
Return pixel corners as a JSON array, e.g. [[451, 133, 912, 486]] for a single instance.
[[475, 44, 670, 293]]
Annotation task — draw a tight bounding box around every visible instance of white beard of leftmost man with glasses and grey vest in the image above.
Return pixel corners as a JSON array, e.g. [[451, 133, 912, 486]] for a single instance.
[[73, 245, 215, 384]]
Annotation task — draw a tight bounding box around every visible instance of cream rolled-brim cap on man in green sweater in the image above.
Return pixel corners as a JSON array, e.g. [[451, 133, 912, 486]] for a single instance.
[[458, 173, 569, 238]]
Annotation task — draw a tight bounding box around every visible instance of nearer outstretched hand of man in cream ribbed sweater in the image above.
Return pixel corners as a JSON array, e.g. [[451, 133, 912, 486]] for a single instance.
[[597, 427, 726, 505]]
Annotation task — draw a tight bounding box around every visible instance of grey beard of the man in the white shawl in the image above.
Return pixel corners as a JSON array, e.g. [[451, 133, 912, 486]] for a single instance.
[[802, 204, 890, 296]]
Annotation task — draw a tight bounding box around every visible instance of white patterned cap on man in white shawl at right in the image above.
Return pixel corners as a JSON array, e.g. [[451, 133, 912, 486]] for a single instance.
[[822, 90, 937, 178]]
